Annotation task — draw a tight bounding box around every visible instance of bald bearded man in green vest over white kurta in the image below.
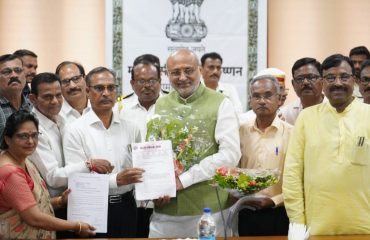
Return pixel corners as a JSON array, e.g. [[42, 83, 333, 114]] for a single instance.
[[149, 49, 240, 238]]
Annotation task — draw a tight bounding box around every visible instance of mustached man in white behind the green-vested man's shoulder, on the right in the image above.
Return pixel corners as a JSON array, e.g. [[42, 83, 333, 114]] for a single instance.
[[200, 52, 243, 115]]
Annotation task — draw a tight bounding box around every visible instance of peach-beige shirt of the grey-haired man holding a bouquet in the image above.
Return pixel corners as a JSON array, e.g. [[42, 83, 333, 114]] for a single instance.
[[240, 116, 293, 206]]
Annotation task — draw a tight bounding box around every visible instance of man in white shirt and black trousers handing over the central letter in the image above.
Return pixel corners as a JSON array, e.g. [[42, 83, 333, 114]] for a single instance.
[[63, 67, 144, 238]]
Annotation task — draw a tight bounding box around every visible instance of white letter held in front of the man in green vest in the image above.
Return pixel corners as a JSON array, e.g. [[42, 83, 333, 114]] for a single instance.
[[132, 140, 176, 201]]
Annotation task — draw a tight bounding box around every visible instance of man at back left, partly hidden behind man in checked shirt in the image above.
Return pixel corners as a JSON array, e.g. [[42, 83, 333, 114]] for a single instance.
[[13, 49, 38, 97]]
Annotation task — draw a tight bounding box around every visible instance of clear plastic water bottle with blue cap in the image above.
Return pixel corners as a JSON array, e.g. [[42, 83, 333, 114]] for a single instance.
[[198, 208, 216, 240]]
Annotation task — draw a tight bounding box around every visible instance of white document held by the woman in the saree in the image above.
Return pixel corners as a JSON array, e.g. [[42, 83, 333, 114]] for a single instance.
[[67, 173, 109, 233]]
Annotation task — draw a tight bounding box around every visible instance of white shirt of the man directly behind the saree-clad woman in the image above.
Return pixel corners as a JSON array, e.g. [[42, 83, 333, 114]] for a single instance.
[[28, 108, 68, 197]]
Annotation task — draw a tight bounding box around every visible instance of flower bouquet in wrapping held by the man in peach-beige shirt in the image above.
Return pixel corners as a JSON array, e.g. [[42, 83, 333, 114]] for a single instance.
[[211, 167, 280, 198]]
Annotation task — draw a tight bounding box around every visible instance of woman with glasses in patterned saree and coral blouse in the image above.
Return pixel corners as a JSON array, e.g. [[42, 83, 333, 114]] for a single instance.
[[0, 111, 95, 239]]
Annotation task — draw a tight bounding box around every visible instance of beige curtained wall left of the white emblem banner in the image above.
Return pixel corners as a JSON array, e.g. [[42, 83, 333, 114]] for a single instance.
[[0, 0, 106, 72]]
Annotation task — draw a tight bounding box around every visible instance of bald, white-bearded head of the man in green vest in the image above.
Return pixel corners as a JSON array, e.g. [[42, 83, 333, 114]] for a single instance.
[[167, 49, 200, 98]]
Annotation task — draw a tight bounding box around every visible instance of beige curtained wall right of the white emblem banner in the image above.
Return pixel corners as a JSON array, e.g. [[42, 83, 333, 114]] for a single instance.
[[268, 0, 370, 102]]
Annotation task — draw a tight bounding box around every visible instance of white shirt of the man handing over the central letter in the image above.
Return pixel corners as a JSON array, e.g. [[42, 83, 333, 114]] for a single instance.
[[63, 111, 140, 195]]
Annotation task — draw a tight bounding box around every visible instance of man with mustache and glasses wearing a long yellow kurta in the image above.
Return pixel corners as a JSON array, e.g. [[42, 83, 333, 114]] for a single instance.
[[283, 54, 370, 235]]
